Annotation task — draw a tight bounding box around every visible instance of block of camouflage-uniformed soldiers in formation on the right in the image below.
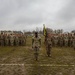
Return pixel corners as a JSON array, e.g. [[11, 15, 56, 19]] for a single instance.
[[50, 33, 75, 47]]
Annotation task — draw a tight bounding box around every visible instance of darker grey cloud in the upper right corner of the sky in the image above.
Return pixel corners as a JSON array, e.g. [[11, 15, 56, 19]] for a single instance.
[[59, 0, 75, 21]]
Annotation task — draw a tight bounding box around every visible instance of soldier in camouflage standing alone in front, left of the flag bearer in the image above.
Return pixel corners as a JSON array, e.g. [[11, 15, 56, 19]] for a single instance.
[[32, 32, 41, 61]]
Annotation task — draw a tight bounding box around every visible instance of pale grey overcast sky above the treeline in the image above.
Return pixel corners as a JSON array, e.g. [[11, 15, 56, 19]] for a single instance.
[[0, 0, 75, 31]]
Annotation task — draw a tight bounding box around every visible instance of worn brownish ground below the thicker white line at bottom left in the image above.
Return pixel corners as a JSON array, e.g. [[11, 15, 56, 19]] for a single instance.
[[0, 64, 26, 75]]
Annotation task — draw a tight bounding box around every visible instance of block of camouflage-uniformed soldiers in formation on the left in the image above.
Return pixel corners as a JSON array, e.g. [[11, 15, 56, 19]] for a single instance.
[[0, 33, 26, 46]]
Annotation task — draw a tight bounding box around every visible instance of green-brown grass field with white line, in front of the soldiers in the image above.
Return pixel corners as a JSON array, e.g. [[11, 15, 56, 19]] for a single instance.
[[0, 37, 75, 75]]
